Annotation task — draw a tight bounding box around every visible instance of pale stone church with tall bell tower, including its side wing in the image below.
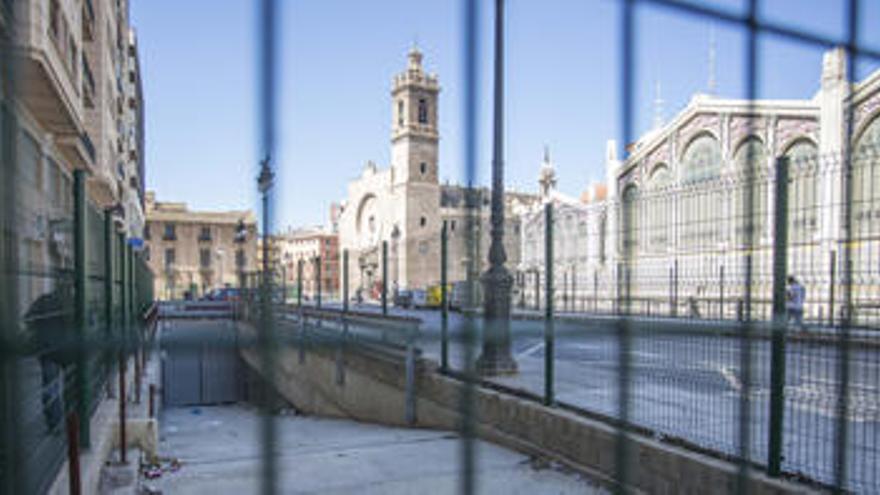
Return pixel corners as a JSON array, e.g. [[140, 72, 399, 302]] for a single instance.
[[338, 49, 537, 297]]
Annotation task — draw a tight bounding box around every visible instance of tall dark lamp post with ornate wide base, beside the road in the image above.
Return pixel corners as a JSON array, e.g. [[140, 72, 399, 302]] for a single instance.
[[477, 0, 516, 376]]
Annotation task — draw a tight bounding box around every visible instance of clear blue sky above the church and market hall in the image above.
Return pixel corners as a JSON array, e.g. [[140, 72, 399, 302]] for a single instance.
[[132, 0, 880, 228]]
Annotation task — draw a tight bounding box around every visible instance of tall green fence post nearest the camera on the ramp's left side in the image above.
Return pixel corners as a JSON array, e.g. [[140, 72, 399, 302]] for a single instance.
[[73, 170, 91, 448]]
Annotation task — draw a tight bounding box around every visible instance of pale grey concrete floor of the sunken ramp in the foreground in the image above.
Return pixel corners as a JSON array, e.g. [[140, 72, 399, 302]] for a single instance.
[[150, 405, 604, 495]]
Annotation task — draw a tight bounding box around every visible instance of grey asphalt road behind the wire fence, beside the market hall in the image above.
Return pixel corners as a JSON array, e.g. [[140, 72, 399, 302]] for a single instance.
[[298, 300, 880, 492]]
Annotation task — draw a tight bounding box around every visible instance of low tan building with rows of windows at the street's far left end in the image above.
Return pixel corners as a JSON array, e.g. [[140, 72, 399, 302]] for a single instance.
[[144, 192, 257, 300]]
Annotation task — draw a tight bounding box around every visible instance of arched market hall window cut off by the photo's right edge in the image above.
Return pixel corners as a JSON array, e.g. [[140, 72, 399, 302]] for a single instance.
[[852, 116, 880, 234]]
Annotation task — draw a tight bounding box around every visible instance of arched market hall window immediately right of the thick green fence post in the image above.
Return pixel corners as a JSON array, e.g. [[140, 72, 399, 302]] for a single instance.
[[784, 139, 819, 243]]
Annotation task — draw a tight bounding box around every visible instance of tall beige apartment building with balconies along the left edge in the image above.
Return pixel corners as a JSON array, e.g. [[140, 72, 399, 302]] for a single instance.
[[0, 0, 144, 312]]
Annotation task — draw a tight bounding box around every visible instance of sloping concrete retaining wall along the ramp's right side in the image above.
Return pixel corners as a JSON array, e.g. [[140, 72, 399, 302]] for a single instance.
[[241, 326, 809, 494]]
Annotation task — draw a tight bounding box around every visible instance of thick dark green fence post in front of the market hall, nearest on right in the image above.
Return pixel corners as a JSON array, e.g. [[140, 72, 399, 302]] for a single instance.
[[767, 157, 788, 476]]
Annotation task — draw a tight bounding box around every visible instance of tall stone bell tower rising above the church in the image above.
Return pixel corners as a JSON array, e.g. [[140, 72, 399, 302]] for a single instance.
[[391, 47, 440, 185]]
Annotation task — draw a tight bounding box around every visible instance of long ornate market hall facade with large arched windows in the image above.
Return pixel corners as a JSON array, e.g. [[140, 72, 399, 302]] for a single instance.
[[520, 49, 880, 322]]
